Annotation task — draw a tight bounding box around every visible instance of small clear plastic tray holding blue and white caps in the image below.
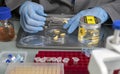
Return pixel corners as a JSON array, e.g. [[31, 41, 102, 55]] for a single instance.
[[0, 51, 27, 64]]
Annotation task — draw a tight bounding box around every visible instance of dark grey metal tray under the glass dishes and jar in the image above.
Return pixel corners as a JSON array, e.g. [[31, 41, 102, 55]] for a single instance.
[[16, 15, 112, 49]]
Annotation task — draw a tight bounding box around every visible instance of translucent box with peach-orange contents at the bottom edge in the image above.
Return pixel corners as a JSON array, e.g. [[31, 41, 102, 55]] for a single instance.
[[5, 63, 64, 74]]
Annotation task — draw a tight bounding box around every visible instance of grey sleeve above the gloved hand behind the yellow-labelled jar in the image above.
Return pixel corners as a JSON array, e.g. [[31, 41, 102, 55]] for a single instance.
[[101, 0, 120, 21]]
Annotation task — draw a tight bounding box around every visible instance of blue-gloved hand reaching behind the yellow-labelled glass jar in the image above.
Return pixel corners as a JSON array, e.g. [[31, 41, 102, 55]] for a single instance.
[[63, 7, 108, 34]]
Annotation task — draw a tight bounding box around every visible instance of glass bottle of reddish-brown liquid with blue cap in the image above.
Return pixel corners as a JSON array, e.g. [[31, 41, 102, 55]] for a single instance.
[[0, 7, 15, 42]]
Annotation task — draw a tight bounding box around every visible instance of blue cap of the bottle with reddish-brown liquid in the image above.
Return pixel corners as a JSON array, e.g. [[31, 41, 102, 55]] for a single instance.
[[0, 7, 11, 20]]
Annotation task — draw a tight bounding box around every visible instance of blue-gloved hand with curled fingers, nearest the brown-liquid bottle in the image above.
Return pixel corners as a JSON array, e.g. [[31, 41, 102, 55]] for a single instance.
[[19, 1, 47, 33]]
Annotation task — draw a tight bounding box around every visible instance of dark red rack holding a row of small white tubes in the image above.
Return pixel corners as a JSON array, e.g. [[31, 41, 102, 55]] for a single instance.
[[34, 50, 89, 74]]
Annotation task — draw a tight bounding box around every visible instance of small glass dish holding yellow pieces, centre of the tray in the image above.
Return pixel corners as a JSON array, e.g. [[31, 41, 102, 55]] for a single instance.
[[46, 26, 66, 45]]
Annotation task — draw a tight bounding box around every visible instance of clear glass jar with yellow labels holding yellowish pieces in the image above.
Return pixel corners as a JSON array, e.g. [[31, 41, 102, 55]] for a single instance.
[[78, 15, 101, 46]]
